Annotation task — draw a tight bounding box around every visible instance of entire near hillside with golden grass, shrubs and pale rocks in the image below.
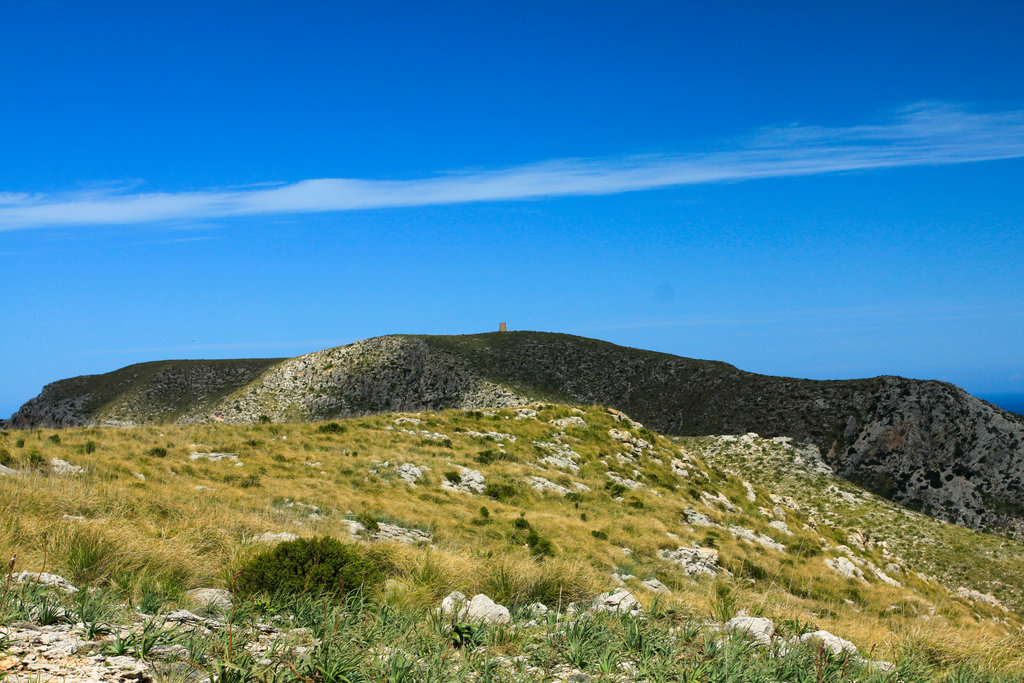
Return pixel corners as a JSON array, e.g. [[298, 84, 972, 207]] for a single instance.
[[0, 403, 1024, 682]]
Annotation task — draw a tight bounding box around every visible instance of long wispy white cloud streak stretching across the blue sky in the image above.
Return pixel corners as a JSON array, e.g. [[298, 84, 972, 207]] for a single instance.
[[0, 102, 1024, 230]]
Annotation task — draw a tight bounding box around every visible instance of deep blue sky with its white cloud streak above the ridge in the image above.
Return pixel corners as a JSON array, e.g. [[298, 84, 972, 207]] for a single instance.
[[0, 0, 1024, 415]]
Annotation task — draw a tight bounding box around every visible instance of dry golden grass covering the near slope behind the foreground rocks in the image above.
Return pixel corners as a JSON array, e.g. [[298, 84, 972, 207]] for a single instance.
[[0, 407, 1024, 672]]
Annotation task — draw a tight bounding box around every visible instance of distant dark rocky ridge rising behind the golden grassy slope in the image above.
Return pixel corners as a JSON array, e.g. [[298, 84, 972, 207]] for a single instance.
[[11, 332, 1024, 538]]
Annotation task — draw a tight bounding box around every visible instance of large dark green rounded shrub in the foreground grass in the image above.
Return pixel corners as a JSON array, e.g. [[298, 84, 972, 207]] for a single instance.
[[236, 537, 386, 595]]
